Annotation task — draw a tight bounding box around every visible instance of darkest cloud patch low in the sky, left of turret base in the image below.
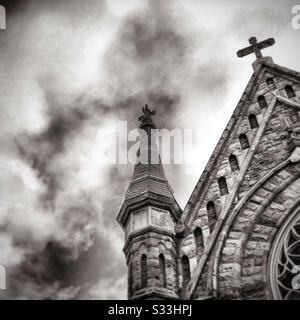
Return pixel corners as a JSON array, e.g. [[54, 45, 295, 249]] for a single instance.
[[6, 202, 125, 299]]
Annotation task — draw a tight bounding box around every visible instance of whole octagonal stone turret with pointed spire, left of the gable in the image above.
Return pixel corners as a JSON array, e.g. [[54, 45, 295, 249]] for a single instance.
[[117, 105, 181, 299]]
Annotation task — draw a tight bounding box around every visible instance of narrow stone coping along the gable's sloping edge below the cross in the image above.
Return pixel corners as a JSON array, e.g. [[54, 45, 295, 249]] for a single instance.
[[181, 59, 300, 225]]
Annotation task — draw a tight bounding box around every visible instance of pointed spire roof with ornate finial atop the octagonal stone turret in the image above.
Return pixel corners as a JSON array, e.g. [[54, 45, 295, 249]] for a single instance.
[[118, 105, 181, 226]]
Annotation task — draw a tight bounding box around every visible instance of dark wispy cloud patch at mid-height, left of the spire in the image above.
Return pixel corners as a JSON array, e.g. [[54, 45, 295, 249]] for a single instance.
[[17, 91, 89, 202]]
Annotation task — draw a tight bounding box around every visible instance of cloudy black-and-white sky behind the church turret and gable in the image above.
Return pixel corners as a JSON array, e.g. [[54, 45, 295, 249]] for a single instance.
[[0, 0, 300, 299]]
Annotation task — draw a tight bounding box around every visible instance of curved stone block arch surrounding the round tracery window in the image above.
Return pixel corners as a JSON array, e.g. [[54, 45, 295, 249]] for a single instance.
[[218, 164, 300, 299]]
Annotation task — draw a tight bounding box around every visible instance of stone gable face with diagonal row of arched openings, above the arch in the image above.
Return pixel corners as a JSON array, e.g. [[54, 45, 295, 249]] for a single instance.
[[179, 60, 300, 300]]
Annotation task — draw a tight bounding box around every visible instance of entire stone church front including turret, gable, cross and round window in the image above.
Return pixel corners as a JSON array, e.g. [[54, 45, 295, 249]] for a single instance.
[[117, 38, 300, 299]]
